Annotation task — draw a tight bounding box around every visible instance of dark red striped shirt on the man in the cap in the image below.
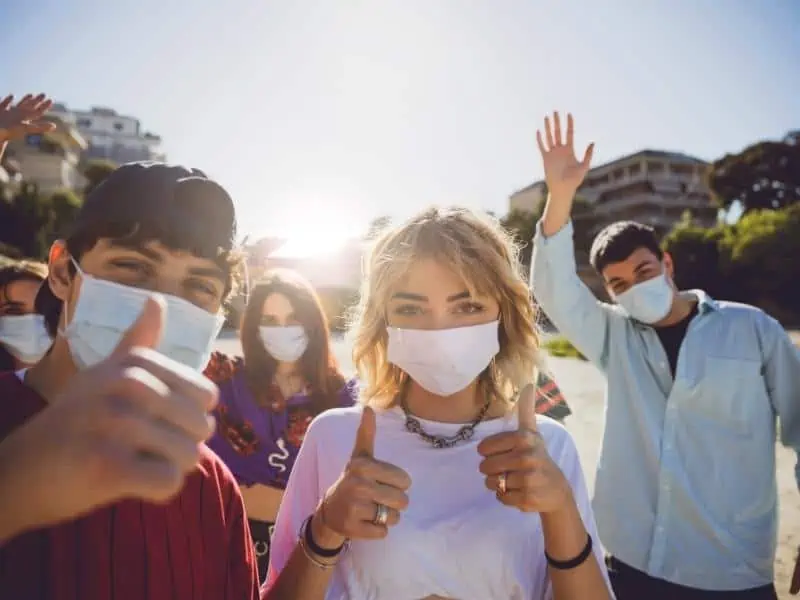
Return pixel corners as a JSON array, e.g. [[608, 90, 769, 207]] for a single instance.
[[0, 373, 258, 600]]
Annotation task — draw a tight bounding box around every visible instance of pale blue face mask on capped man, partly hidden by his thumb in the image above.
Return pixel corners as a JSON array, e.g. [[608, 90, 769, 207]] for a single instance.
[[59, 261, 225, 371]]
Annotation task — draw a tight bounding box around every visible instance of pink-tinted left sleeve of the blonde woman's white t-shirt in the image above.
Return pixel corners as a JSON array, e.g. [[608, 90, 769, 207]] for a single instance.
[[262, 412, 321, 595]]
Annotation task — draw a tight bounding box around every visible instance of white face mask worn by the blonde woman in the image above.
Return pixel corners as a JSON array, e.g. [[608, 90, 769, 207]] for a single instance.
[[388, 321, 500, 396]]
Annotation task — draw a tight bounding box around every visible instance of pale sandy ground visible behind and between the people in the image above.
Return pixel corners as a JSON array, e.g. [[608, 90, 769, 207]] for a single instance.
[[217, 335, 800, 600]]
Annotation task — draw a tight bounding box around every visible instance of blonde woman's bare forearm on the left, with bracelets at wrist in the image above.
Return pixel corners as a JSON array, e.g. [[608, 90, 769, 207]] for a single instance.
[[261, 513, 344, 600]]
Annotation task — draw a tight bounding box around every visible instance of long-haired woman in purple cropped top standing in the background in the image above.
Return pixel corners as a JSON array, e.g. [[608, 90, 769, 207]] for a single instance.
[[205, 270, 357, 580]]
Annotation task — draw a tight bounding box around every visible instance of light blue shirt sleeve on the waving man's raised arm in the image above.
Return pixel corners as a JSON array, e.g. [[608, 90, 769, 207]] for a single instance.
[[531, 221, 622, 369]]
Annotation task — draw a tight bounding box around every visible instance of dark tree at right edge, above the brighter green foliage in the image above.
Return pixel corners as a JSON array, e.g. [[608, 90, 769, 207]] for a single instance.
[[708, 131, 800, 212]]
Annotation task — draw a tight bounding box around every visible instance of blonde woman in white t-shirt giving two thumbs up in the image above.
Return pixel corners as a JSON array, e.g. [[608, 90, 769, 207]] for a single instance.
[[262, 209, 610, 600]]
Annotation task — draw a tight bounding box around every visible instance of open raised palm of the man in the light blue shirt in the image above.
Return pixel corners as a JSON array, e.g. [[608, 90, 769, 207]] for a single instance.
[[536, 112, 594, 197]]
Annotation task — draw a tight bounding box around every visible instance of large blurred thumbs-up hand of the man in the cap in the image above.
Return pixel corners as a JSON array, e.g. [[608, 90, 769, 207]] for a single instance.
[[0, 298, 217, 535]]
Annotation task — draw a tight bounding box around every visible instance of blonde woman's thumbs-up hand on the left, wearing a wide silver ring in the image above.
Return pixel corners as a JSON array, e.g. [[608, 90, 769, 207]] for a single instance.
[[312, 406, 411, 548]]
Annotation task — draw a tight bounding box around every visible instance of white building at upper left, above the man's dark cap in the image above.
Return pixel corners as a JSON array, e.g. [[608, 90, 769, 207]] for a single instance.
[[50, 104, 164, 163]]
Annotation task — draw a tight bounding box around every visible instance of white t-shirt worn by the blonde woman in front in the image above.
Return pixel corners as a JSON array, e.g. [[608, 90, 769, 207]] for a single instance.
[[266, 406, 606, 600]]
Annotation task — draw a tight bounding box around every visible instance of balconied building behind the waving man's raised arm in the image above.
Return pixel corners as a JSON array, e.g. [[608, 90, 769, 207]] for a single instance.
[[509, 150, 718, 233]]
